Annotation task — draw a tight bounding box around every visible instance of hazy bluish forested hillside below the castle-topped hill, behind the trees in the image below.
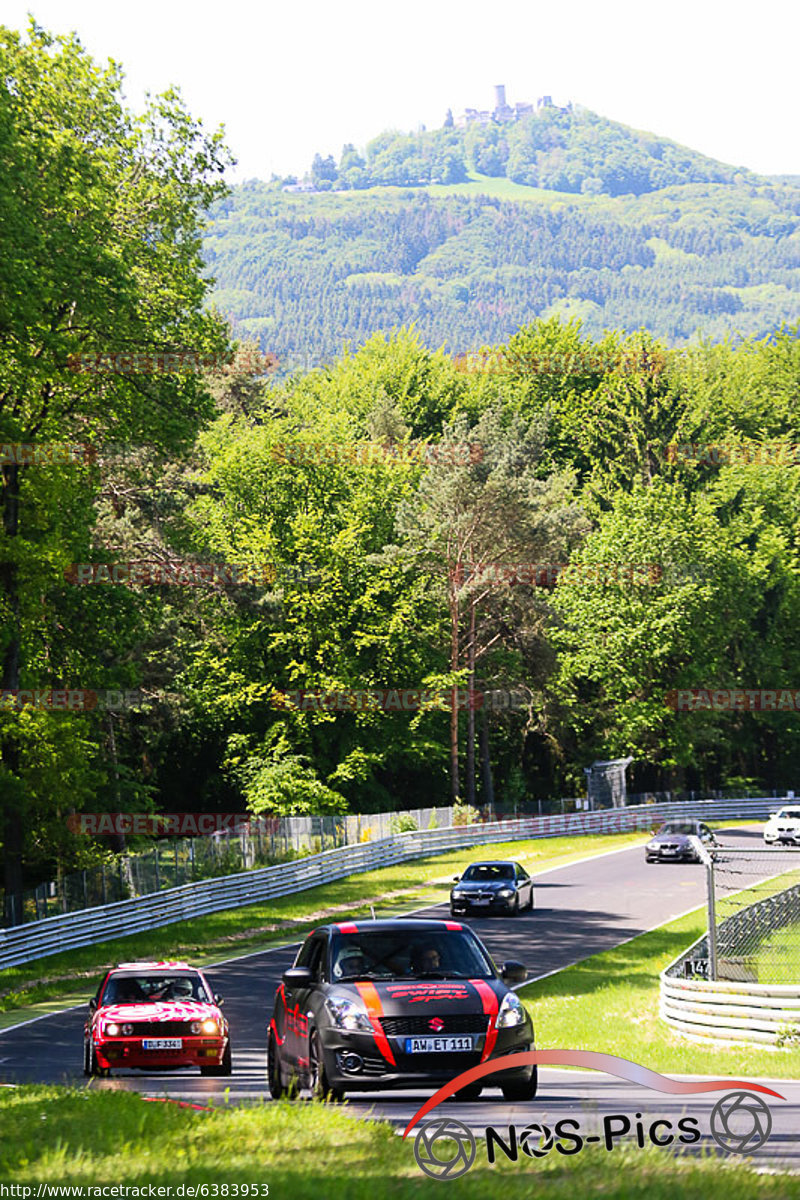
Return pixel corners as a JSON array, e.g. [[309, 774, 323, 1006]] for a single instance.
[[205, 178, 800, 357]]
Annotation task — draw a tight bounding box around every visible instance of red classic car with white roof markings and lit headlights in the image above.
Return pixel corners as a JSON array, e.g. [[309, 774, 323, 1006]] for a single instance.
[[83, 962, 231, 1075]]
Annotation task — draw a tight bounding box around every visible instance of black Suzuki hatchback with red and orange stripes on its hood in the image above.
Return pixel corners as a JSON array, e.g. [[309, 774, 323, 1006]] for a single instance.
[[267, 919, 537, 1100]]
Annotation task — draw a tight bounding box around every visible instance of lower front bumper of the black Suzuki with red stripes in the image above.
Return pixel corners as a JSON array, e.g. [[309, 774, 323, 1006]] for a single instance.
[[319, 1021, 534, 1092]]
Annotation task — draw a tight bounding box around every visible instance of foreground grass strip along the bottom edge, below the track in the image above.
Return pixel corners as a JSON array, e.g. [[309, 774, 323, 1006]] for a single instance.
[[0, 1086, 800, 1200]]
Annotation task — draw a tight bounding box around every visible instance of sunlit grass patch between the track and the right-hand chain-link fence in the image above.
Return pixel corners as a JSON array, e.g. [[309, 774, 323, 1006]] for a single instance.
[[519, 908, 800, 1080]]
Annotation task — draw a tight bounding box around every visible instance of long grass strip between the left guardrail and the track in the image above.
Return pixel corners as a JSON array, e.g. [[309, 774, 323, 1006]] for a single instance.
[[0, 833, 645, 1028]]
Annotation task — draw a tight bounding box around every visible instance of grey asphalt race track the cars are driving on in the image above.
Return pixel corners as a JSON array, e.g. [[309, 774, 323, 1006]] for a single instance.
[[0, 829, 800, 1170]]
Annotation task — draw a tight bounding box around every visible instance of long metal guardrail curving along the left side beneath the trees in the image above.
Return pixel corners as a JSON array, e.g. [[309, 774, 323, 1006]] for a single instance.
[[0, 798, 783, 970]]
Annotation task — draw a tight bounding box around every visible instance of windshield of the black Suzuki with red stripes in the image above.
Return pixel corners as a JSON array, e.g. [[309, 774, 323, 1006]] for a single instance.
[[331, 928, 495, 980]]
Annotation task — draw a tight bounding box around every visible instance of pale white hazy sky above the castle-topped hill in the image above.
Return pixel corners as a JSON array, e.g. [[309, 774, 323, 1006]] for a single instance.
[[6, 0, 800, 179]]
